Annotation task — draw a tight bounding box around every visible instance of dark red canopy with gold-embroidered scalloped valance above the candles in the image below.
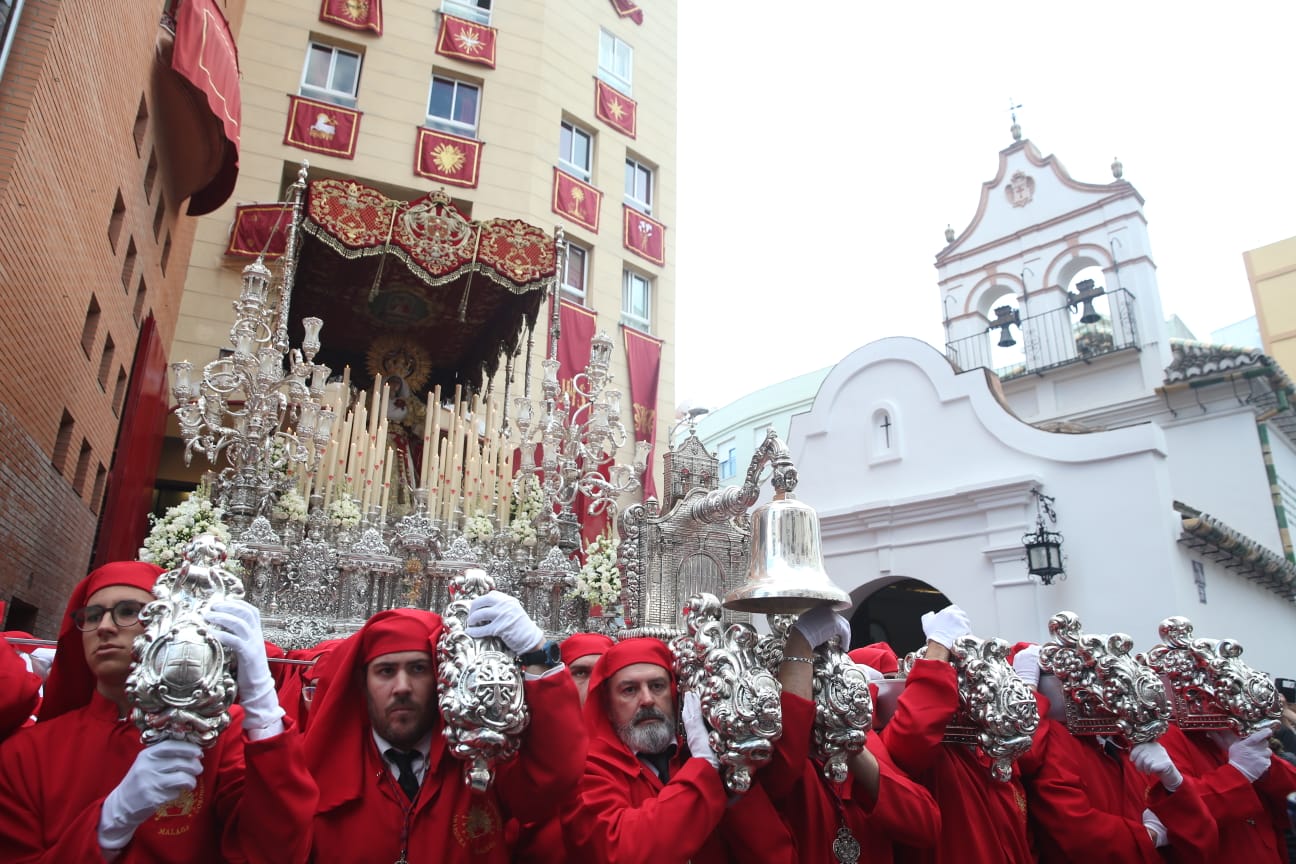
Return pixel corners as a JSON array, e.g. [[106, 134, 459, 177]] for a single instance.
[[292, 179, 556, 382]]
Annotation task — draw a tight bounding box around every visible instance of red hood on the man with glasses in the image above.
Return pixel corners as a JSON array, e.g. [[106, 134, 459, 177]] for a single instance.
[[40, 561, 165, 720]]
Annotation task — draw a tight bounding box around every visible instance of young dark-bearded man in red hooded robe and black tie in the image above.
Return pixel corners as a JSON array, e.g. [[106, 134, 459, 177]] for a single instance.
[[306, 592, 586, 864]]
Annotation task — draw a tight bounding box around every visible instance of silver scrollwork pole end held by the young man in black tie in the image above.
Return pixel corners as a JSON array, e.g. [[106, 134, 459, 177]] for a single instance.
[[437, 569, 531, 793]]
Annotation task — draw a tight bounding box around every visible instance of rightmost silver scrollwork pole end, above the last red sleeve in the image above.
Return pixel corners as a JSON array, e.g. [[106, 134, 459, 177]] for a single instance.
[[1138, 615, 1282, 736]]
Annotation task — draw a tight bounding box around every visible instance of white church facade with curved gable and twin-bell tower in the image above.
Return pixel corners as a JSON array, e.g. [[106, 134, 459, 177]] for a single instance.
[[722, 130, 1296, 675]]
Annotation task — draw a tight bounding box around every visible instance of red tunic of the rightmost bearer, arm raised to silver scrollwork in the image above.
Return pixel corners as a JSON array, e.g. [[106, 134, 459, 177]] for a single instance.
[[1161, 724, 1296, 864]]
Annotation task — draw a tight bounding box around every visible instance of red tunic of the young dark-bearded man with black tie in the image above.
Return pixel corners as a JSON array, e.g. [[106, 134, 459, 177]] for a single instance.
[[311, 671, 584, 864]]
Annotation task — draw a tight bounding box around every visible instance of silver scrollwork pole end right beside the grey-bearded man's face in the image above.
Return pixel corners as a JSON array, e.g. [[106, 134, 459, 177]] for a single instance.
[[670, 593, 783, 793]]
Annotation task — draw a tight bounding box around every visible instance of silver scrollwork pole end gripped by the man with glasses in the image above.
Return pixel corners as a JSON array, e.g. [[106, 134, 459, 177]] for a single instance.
[[126, 534, 244, 747]]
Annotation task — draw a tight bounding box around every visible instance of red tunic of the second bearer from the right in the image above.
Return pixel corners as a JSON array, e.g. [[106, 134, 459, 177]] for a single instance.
[[1017, 718, 1218, 864]]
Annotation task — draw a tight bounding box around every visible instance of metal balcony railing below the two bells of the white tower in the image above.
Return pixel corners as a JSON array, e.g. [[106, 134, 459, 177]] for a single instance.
[[945, 289, 1139, 381]]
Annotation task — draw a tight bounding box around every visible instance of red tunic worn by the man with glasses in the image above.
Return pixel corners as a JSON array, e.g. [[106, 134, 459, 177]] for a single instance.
[[0, 693, 318, 864]]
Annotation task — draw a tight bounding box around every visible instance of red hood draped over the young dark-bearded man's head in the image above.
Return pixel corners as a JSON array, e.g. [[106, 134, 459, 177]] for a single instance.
[[305, 609, 445, 811]]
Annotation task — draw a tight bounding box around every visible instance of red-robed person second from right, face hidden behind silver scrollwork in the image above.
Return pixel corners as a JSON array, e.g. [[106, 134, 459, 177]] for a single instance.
[[1012, 642, 1218, 864]]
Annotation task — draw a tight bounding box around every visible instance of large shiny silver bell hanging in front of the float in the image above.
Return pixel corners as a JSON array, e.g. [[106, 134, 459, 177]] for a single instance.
[[724, 497, 850, 615]]
